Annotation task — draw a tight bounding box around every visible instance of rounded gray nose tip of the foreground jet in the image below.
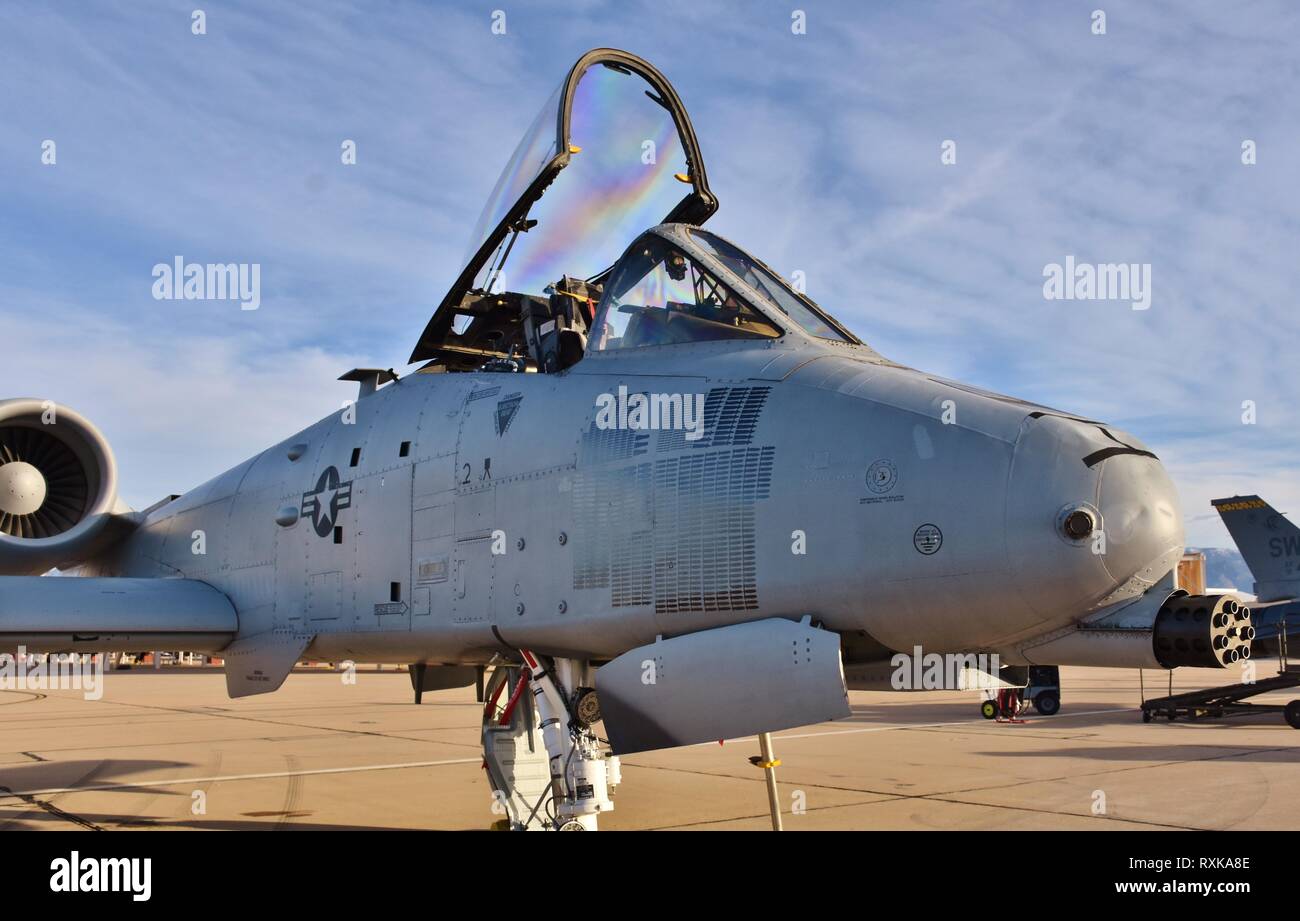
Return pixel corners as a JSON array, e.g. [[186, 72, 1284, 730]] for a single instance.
[[1008, 415, 1183, 621]]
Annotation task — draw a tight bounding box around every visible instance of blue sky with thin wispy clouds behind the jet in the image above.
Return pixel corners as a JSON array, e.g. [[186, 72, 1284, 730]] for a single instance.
[[0, 0, 1300, 546]]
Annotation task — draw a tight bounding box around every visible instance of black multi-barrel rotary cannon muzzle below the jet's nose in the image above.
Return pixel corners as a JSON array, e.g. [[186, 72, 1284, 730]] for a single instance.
[[1154, 592, 1255, 669]]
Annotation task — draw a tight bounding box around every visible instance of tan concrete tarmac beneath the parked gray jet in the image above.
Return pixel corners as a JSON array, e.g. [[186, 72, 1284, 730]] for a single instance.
[[0, 661, 1300, 831]]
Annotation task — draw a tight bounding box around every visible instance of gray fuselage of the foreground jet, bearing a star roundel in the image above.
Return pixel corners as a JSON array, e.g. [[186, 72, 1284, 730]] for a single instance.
[[83, 327, 1182, 663]]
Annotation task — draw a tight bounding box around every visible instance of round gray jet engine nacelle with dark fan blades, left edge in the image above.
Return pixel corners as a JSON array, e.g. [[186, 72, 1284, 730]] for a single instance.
[[0, 398, 117, 575]]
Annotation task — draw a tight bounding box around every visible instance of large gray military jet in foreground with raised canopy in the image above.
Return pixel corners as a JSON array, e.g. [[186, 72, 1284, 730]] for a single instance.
[[0, 48, 1248, 829]]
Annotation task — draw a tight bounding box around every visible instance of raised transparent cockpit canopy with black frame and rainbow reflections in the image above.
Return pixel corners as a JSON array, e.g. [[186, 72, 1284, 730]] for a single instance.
[[411, 48, 718, 369]]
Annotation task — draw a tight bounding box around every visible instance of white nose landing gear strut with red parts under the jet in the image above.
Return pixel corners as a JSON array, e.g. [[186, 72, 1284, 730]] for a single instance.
[[482, 649, 620, 831]]
